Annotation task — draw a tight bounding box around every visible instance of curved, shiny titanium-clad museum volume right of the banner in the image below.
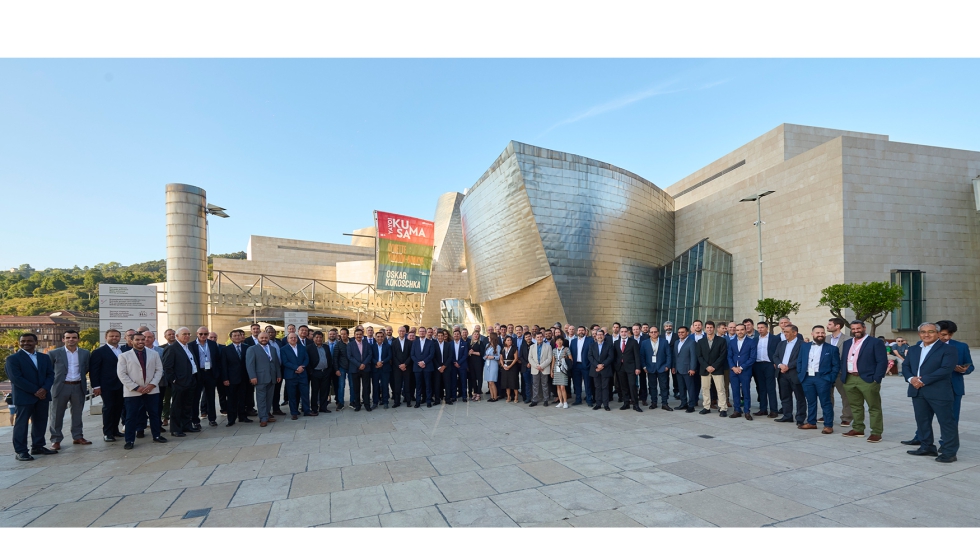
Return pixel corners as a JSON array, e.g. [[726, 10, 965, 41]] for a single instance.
[[461, 142, 674, 324]]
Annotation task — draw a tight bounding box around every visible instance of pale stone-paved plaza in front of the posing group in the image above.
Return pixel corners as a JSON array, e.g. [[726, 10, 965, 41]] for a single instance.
[[0, 376, 980, 527]]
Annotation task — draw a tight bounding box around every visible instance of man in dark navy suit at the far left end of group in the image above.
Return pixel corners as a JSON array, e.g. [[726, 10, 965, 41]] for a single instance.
[[4, 333, 57, 461]]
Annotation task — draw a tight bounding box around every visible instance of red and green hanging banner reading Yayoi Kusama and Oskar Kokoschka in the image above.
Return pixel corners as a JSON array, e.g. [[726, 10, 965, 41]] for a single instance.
[[374, 210, 435, 294]]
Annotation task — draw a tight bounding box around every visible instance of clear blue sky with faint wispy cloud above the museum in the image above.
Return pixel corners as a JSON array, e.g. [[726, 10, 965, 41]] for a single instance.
[[0, 59, 980, 269]]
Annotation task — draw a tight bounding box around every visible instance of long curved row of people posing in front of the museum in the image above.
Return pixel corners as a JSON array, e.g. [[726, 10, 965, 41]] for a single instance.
[[6, 317, 973, 462]]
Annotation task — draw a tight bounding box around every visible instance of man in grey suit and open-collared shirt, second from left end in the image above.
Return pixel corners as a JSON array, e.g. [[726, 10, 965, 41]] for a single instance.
[[48, 330, 92, 451]]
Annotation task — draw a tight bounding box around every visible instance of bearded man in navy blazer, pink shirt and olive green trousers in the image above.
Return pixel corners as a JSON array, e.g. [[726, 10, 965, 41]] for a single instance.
[[840, 321, 888, 443]]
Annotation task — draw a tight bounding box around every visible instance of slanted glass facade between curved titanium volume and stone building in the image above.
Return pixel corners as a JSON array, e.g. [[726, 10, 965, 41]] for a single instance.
[[657, 239, 735, 329]]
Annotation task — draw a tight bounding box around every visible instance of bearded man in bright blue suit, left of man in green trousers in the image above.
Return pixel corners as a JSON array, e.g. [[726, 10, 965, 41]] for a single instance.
[[796, 325, 840, 434]]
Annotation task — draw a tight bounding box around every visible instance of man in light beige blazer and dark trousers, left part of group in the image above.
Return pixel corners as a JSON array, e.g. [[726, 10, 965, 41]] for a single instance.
[[116, 333, 167, 449]]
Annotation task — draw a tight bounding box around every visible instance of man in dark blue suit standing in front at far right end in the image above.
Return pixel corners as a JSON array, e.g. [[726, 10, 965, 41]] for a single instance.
[[902, 323, 960, 463]]
